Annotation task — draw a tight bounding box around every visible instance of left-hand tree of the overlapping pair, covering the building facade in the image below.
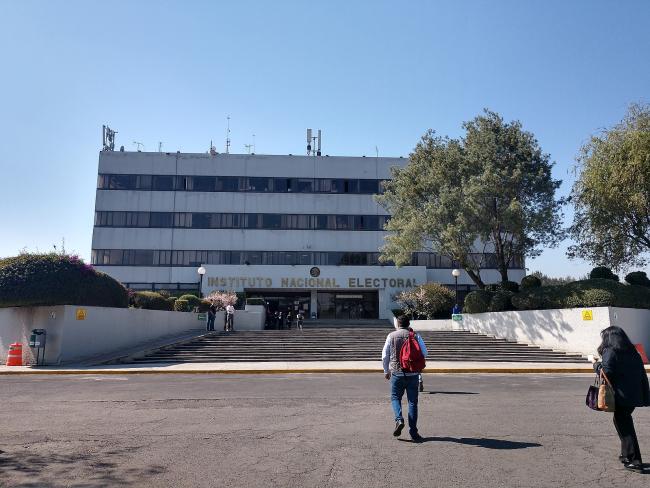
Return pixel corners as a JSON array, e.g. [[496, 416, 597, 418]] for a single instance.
[[377, 130, 484, 288]]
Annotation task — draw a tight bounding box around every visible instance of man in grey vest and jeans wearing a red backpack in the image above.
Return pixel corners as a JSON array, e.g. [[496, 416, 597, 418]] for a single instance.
[[381, 315, 427, 442]]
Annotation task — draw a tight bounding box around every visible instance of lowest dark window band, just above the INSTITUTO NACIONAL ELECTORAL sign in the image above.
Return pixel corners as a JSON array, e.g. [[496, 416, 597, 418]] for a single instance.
[[91, 249, 522, 269]]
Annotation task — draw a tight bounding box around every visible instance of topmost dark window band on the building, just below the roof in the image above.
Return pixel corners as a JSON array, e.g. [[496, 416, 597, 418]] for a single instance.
[[97, 174, 384, 195]]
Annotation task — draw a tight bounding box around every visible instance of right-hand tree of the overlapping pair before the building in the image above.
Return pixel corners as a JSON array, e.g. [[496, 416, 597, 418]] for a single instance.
[[463, 110, 564, 281]]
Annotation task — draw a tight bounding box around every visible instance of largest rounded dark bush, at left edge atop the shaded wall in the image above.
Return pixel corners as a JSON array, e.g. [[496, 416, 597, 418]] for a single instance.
[[0, 253, 129, 308]]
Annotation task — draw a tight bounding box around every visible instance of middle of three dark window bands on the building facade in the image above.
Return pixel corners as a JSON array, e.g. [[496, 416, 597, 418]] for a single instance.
[[95, 211, 388, 231]]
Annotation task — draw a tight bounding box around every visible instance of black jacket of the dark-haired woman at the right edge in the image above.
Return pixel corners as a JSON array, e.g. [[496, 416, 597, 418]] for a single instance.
[[594, 349, 650, 407]]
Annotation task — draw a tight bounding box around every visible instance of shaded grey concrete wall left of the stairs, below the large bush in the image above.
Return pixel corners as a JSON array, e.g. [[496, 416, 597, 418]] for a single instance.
[[0, 305, 205, 365]]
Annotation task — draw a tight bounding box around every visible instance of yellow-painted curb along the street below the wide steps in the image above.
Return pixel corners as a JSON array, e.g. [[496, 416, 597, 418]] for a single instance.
[[0, 368, 594, 376]]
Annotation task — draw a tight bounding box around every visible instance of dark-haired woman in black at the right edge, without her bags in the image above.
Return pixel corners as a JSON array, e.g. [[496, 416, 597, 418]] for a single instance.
[[594, 326, 650, 472]]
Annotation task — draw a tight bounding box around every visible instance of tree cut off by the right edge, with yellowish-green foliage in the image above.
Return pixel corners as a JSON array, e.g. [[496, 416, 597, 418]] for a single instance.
[[567, 104, 650, 270]]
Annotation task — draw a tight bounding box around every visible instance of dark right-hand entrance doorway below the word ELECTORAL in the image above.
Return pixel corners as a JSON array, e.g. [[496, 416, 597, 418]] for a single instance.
[[317, 291, 379, 320]]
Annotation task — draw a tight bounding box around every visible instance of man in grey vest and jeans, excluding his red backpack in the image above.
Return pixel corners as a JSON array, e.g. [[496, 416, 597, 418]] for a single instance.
[[381, 315, 427, 442]]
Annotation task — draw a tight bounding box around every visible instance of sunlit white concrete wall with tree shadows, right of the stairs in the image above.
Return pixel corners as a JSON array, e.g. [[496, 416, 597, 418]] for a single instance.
[[412, 307, 650, 355]]
